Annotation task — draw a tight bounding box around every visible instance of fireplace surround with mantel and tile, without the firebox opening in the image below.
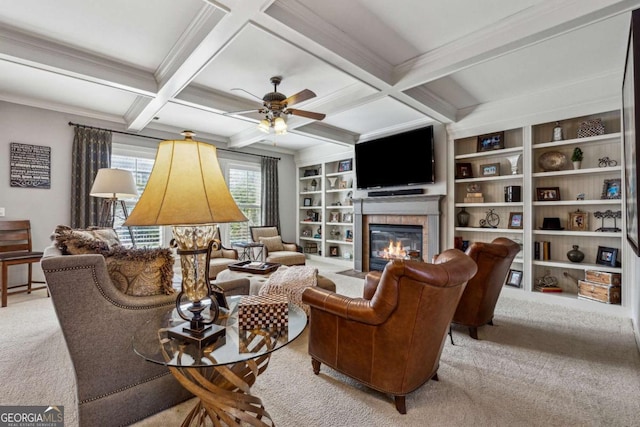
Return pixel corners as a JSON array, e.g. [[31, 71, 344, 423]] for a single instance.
[[353, 195, 443, 271]]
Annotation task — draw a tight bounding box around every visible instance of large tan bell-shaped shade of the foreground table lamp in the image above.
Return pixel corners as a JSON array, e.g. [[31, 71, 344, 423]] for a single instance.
[[125, 132, 247, 225]]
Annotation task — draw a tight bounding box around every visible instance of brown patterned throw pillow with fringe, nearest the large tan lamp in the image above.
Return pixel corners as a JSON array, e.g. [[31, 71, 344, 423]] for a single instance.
[[105, 246, 175, 296]]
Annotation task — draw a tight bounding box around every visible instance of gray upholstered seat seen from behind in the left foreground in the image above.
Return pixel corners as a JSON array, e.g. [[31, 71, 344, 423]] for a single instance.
[[41, 246, 249, 426]]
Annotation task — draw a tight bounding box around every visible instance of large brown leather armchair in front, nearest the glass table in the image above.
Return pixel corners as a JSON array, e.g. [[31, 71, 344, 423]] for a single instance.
[[302, 249, 476, 414]]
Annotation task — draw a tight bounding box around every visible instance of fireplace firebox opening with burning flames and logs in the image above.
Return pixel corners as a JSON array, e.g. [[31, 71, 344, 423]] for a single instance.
[[369, 224, 422, 271]]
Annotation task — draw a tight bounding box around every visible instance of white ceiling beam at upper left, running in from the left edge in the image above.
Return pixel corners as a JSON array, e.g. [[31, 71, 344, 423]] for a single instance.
[[0, 26, 157, 96]]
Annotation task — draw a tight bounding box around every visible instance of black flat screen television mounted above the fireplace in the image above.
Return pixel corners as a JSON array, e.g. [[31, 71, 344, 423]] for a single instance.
[[355, 126, 436, 190]]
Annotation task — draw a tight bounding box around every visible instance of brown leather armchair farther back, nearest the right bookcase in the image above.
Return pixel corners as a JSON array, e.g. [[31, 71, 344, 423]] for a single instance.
[[453, 237, 520, 339]]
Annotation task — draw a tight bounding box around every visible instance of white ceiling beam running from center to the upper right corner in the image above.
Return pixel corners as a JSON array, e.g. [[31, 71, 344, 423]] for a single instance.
[[394, 0, 638, 90]]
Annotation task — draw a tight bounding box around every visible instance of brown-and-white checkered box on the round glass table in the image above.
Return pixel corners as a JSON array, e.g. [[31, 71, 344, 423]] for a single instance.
[[238, 295, 289, 330]]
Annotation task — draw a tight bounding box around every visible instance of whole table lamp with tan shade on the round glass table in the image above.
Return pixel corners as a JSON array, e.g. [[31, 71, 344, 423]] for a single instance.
[[125, 131, 247, 346]]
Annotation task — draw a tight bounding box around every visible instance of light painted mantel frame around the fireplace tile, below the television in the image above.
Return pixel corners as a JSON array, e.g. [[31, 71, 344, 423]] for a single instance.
[[353, 195, 444, 271]]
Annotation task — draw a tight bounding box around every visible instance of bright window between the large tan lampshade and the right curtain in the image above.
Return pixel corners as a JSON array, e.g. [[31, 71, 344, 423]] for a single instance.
[[221, 161, 262, 243]]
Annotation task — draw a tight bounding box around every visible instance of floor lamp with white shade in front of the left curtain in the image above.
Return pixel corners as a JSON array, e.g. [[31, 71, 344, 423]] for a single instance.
[[89, 168, 138, 246]]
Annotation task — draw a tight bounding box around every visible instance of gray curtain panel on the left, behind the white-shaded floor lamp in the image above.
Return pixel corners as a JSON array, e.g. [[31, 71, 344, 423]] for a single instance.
[[71, 126, 112, 228]]
